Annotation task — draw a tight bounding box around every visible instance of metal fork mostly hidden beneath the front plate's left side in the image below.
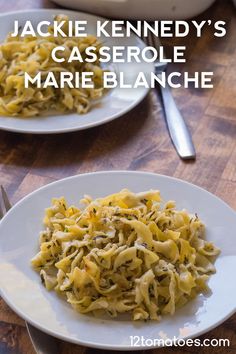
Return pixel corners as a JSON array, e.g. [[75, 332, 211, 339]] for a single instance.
[[0, 186, 59, 354]]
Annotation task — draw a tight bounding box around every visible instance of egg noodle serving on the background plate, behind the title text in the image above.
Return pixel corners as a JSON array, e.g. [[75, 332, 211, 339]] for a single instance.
[[0, 15, 104, 117]]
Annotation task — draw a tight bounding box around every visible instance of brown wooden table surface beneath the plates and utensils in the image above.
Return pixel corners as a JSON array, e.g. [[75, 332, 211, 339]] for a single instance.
[[0, 0, 236, 354]]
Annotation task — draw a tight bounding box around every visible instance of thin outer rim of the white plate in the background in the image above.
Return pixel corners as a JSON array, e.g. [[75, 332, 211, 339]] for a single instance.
[[0, 8, 152, 135]]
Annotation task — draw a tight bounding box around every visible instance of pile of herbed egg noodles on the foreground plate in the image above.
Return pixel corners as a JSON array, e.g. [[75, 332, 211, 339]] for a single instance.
[[31, 189, 220, 320]]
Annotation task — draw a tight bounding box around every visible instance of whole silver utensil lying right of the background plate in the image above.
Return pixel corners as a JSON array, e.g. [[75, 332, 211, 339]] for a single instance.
[[142, 31, 196, 159]]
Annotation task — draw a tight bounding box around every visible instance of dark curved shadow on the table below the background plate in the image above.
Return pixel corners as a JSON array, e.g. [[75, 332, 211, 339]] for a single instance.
[[0, 96, 155, 167]]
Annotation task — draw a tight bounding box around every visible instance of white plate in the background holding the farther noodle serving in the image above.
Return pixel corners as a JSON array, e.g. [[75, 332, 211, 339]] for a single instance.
[[0, 9, 154, 134]]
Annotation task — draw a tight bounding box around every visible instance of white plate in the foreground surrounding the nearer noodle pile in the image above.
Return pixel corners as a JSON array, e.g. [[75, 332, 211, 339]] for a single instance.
[[0, 171, 236, 350]]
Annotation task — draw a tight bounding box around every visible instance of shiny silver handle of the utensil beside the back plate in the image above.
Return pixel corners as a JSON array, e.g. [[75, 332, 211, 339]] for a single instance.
[[161, 86, 196, 159]]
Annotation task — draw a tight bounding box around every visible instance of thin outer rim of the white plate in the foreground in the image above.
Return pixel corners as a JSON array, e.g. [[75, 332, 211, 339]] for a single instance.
[[0, 170, 236, 351]]
